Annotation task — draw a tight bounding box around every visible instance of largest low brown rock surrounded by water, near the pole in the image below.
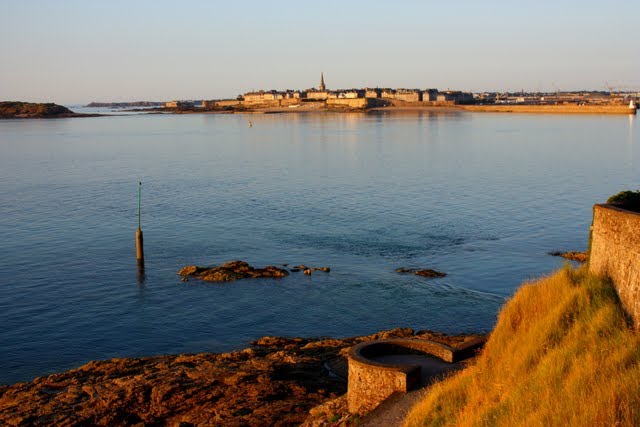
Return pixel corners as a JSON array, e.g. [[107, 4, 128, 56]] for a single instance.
[[178, 261, 289, 282]]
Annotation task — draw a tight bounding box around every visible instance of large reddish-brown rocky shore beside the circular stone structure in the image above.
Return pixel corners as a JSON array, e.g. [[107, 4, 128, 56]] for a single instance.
[[0, 328, 477, 427]]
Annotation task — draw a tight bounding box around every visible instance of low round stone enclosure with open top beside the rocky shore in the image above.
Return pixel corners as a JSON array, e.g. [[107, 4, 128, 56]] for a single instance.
[[347, 339, 484, 414]]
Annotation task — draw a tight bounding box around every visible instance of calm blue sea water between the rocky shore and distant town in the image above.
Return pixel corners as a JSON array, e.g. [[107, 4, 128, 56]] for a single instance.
[[0, 113, 640, 383]]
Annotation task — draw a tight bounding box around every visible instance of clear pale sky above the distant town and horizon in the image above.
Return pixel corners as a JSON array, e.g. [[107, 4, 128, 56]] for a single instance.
[[0, 0, 640, 104]]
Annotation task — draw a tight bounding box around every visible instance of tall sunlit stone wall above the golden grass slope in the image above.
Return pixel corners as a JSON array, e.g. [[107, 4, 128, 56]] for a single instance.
[[589, 205, 640, 330]]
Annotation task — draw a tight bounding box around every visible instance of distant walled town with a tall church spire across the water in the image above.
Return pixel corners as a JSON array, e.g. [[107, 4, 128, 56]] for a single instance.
[[87, 73, 640, 112]]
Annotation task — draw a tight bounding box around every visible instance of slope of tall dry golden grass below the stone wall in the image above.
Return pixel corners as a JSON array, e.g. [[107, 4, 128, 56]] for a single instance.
[[405, 266, 640, 427]]
